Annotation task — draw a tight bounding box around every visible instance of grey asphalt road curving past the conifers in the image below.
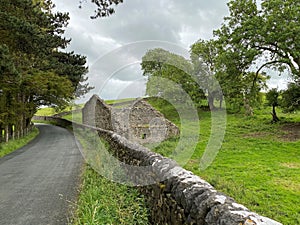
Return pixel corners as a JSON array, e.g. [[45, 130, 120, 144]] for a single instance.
[[0, 124, 83, 225]]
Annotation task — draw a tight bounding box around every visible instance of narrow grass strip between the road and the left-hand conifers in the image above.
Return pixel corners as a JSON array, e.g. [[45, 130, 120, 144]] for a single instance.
[[0, 128, 39, 158]]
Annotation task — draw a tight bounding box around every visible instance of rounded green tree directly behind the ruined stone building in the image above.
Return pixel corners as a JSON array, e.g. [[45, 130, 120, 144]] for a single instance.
[[141, 48, 203, 103]]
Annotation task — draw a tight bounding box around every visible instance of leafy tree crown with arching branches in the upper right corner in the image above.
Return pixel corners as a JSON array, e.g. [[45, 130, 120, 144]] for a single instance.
[[215, 0, 300, 82]]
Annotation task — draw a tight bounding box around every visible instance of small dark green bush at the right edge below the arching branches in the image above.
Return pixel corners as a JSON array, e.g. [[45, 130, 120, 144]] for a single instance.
[[281, 82, 300, 112]]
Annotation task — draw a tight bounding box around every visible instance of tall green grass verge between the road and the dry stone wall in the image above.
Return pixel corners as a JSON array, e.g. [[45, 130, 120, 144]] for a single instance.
[[73, 124, 149, 225]]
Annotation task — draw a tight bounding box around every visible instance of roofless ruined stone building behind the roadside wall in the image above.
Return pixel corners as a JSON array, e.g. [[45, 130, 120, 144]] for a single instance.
[[82, 95, 179, 144]]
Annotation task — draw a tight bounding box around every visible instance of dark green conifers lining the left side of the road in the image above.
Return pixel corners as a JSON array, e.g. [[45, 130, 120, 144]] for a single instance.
[[0, 0, 87, 141]]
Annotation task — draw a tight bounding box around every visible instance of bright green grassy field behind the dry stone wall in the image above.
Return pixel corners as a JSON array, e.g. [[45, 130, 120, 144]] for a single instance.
[[150, 100, 300, 225]]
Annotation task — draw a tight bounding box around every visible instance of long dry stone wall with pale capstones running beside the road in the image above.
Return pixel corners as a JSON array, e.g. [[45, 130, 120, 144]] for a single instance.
[[34, 117, 282, 225]]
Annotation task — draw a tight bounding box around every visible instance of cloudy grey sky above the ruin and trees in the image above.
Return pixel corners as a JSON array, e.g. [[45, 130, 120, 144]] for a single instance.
[[53, 0, 286, 101]]
